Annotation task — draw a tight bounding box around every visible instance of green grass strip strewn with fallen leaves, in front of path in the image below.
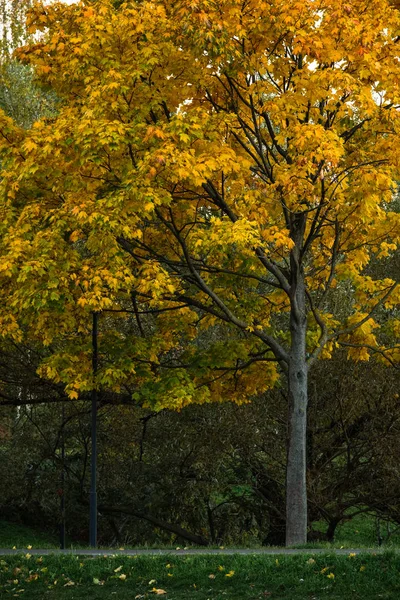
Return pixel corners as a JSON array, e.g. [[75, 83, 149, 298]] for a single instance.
[[0, 553, 400, 600]]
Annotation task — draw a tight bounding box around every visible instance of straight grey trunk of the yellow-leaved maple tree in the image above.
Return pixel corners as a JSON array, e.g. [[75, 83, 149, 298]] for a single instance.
[[286, 214, 308, 546]]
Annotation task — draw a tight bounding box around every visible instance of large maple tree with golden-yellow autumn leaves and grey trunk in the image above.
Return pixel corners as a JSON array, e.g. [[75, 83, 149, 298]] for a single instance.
[[0, 0, 400, 544]]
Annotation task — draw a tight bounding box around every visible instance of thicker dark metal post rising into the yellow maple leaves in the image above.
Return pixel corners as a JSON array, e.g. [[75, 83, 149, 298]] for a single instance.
[[89, 312, 98, 548]]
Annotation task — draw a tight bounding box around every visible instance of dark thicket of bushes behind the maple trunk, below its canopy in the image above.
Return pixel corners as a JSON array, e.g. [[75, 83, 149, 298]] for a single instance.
[[0, 351, 400, 546]]
